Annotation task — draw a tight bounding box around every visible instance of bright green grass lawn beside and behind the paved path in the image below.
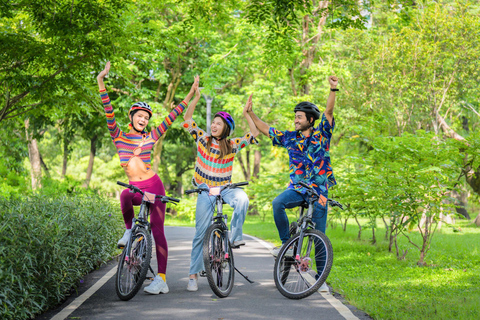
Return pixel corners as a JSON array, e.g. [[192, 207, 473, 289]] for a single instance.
[[167, 211, 480, 319]]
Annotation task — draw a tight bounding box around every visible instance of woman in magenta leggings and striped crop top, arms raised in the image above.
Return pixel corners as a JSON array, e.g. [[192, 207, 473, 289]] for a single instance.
[[97, 62, 198, 294]]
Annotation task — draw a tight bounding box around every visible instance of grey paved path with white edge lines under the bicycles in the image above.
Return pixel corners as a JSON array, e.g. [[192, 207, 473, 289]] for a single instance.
[[37, 227, 370, 320]]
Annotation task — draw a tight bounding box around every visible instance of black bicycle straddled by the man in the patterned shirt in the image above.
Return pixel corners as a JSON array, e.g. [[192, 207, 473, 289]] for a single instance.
[[273, 182, 343, 299]]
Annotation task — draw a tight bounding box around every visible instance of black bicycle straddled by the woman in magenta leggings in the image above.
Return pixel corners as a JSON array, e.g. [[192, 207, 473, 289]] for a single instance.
[[115, 181, 180, 301]]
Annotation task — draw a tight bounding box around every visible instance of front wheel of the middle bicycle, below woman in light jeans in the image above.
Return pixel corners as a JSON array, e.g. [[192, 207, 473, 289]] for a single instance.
[[203, 224, 235, 298]]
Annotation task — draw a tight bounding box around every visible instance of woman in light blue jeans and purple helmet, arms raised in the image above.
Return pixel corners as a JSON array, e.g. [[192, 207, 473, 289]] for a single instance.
[[183, 83, 259, 291]]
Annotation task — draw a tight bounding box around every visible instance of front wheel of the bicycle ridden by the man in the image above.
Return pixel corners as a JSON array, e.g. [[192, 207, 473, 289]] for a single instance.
[[273, 229, 333, 299]]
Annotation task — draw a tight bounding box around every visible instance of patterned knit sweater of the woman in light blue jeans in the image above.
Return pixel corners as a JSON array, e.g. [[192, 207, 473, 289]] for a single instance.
[[182, 119, 258, 187]]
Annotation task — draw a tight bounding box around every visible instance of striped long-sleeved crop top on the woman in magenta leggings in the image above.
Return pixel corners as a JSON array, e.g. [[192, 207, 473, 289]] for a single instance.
[[100, 90, 187, 169]]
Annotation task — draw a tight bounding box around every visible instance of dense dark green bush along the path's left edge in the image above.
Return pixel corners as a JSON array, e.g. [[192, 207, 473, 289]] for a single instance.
[[0, 195, 122, 319]]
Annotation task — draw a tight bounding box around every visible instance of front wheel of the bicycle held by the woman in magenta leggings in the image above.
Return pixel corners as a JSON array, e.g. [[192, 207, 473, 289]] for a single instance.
[[115, 228, 152, 301]]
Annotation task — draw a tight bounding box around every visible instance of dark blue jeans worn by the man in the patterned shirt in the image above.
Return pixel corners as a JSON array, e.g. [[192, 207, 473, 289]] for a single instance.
[[272, 189, 328, 243]]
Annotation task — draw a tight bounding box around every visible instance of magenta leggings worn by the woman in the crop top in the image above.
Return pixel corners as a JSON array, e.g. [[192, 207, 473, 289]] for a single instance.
[[120, 174, 168, 273]]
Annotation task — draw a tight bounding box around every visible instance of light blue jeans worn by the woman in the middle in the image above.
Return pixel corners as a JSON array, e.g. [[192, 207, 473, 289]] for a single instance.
[[190, 183, 248, 274]]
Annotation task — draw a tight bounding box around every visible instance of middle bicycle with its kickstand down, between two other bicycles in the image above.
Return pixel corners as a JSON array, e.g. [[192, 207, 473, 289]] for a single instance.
[[185, 182, 253, 298]]
